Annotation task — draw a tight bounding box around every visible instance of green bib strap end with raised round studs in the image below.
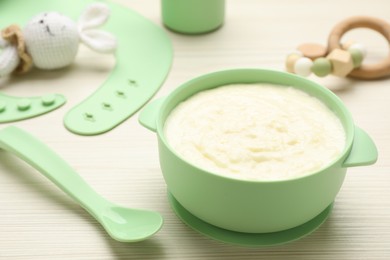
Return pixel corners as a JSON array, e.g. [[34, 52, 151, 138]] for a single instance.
[[0, 92, 66, 123]]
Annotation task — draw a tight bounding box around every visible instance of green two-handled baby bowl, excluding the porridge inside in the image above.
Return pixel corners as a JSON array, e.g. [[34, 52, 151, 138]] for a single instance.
[[139, 69, 378, 233]]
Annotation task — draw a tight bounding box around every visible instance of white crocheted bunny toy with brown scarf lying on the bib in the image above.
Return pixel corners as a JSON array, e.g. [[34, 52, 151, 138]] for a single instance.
[[0, 3, 117, 77]]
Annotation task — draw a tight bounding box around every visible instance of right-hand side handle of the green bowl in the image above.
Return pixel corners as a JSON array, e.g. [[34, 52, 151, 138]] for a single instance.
[[343, 126, 378, 167]]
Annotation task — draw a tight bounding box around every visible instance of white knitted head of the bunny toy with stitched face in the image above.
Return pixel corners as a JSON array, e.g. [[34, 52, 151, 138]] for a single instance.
[[23, 12, 79, 70]]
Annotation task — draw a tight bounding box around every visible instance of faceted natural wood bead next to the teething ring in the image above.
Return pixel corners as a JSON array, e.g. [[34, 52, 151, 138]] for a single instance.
[[326, 49, 353, 77]]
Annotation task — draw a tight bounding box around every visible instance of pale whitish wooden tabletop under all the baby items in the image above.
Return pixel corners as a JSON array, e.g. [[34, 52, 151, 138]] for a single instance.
[[0, 0, 390, 260]]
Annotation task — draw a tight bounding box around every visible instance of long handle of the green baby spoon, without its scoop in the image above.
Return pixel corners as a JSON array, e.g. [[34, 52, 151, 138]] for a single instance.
[[0, 126, 108, 213]]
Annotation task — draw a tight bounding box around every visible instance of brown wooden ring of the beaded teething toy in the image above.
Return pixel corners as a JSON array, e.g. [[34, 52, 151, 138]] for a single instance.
[[328, 16, 390, 79]]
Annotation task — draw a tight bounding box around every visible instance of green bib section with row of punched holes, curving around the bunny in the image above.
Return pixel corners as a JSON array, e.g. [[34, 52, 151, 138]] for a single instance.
[[0, 0, 173, 135]]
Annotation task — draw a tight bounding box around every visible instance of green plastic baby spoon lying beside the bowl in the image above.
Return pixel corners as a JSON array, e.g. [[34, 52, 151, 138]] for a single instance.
[[0, 126, 163, 242]]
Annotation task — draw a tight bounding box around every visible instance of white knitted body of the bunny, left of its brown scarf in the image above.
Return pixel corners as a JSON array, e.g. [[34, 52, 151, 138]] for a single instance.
[[0, 37, 20, 77]]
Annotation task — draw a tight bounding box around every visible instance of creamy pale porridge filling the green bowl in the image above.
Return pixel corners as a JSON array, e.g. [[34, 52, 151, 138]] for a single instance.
[[164, 84, 346, 180]]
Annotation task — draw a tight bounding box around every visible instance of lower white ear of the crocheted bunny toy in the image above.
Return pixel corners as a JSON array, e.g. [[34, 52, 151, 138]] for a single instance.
[[80, 30, 117, 53]]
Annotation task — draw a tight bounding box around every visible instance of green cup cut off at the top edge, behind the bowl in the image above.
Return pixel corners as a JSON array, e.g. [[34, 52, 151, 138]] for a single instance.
[[161, 0, 225, 34]]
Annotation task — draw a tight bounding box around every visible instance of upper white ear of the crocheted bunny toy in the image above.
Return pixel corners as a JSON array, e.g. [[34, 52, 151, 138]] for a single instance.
[[78, 3, 110, 32]]
